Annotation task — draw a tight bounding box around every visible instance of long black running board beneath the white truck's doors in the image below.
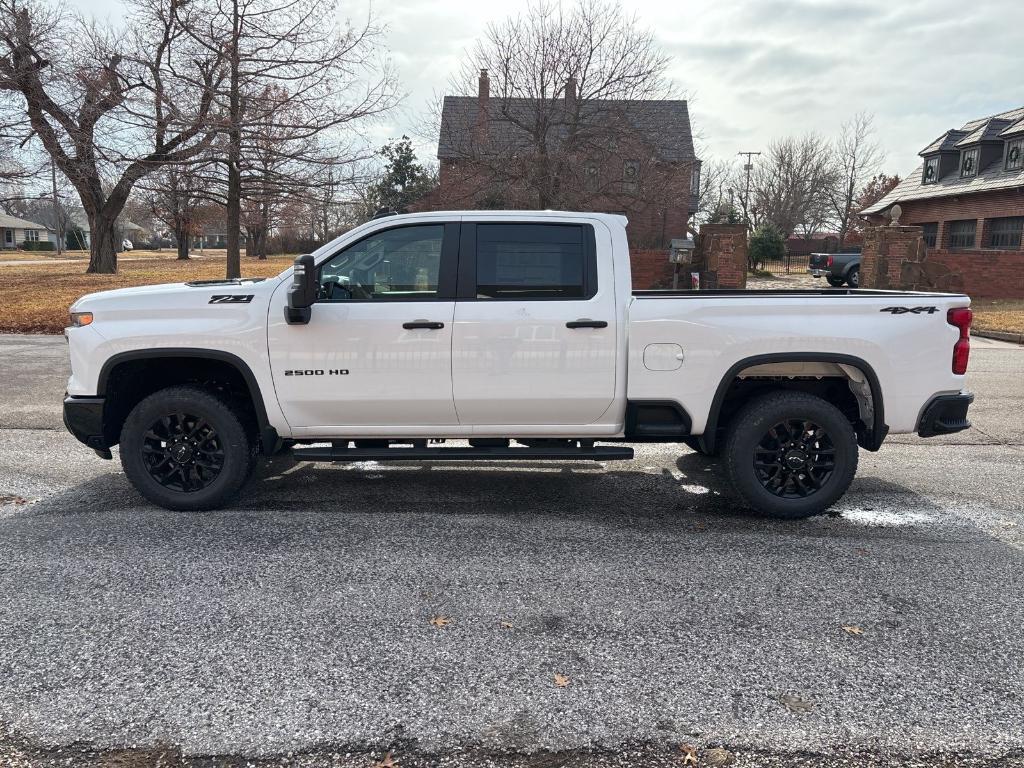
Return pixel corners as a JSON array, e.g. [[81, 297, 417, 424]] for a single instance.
[[292, 445, 633, 462]]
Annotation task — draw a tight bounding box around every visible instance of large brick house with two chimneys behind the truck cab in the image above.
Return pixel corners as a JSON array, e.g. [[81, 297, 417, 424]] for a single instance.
[[416, 70, 700, 249]]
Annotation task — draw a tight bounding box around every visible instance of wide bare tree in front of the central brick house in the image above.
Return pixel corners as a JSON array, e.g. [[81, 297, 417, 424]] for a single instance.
[[440, 0, 691, 228]]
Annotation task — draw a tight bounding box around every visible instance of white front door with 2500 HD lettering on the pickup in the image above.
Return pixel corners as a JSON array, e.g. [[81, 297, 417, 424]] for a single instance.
[[269, 222, 459, 435]]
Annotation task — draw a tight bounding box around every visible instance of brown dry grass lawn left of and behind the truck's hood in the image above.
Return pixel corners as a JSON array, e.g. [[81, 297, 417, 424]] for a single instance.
[[0, 252, 292, 334]]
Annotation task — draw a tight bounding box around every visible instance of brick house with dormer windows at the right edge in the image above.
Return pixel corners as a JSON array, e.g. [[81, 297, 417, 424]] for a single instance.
[[860, 108, 1024, 298]]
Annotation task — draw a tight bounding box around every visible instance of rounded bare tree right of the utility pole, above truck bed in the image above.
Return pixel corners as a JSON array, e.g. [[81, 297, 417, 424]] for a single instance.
[[744, 133, 836, 238]]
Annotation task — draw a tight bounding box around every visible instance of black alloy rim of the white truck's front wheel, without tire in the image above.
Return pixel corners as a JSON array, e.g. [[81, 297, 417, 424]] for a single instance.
[[141, 413, 224, 494]]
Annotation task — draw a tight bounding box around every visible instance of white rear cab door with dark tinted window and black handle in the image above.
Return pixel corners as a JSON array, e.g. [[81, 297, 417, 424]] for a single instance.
[[452, 220, 617, 431]]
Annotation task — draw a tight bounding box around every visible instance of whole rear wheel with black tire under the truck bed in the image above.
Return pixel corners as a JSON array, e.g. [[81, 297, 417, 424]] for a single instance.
[[724, 391, 857, 520]]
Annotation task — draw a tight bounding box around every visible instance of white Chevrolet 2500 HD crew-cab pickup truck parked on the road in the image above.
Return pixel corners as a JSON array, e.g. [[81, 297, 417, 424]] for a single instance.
[[65, 211, 973, 517]]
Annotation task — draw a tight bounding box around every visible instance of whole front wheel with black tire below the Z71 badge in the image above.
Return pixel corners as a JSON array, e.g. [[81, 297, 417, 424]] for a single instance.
[[121, 386, 258, 511]]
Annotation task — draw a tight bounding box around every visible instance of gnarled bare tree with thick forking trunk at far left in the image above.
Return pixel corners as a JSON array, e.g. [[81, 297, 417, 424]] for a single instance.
[[0, 0, 222, 272]]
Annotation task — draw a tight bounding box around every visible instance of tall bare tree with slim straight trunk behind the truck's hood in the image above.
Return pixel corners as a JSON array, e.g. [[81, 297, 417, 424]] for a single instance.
[[184, 0, 394, 278]]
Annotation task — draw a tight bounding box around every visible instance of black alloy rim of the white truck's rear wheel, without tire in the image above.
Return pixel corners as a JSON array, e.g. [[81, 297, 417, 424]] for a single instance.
[[754, 419, 836, 499]]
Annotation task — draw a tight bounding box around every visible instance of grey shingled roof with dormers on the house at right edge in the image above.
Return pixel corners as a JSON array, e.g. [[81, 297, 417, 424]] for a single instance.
[[860, 106, 1024, 216]]
